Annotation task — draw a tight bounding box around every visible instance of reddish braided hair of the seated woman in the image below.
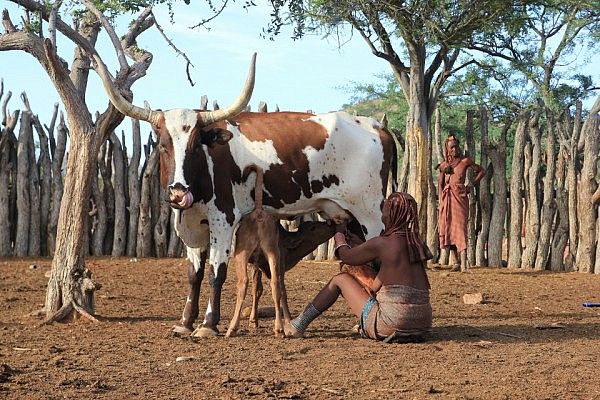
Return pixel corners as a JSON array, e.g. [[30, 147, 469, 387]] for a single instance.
[[382, 192, 433, 264]]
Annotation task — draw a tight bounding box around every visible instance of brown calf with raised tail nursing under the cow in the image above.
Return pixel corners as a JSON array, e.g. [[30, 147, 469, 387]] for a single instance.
[[225, 166, 335, 337]]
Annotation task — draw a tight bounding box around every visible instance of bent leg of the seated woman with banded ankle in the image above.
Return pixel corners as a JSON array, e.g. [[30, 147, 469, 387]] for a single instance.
[[285, 273, 370, 337]]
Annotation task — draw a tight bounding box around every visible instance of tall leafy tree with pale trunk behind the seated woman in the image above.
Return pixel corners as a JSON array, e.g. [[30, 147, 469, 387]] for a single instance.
[[270, 0, 513, 225]]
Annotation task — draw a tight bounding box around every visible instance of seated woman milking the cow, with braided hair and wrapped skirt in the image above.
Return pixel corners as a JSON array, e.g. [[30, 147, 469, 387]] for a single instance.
[[286, 193, 432, 341]]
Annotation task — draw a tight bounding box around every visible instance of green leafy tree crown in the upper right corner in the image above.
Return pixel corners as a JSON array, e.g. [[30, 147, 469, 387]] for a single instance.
[[467, 0, 600, 112]]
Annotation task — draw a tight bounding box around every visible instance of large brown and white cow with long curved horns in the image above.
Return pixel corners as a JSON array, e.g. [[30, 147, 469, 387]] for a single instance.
[[95, 54, 396, 336]]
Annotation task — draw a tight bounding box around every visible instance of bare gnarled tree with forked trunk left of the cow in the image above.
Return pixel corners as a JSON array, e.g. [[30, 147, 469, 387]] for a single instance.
[[0, 0, 159, 321]]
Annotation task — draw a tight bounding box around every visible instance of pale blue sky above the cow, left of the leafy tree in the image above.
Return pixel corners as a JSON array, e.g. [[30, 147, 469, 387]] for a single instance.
[[0, 1, 389, 130]]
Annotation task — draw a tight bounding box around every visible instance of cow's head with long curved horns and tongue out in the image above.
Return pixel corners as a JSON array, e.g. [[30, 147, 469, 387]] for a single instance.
[[96, 53, 256, 209]]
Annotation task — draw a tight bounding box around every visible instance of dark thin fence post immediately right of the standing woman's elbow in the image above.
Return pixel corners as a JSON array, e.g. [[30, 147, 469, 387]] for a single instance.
[[475, 108, 492, 267]]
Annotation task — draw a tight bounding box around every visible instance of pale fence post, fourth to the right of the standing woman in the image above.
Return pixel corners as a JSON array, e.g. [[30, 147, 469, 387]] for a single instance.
[[521, 107, 542, 269]]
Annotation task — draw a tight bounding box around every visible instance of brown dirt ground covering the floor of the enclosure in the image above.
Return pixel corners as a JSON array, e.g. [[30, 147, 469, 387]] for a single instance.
[[0, 258, 600, 399]]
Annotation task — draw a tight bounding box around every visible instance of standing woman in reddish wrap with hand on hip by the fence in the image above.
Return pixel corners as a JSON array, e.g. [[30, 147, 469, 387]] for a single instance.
[[438, 135, 485, 272]]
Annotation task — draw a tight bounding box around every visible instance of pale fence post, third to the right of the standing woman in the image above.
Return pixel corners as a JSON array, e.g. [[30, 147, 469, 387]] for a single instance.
[[508, 112, 529, 268]]
